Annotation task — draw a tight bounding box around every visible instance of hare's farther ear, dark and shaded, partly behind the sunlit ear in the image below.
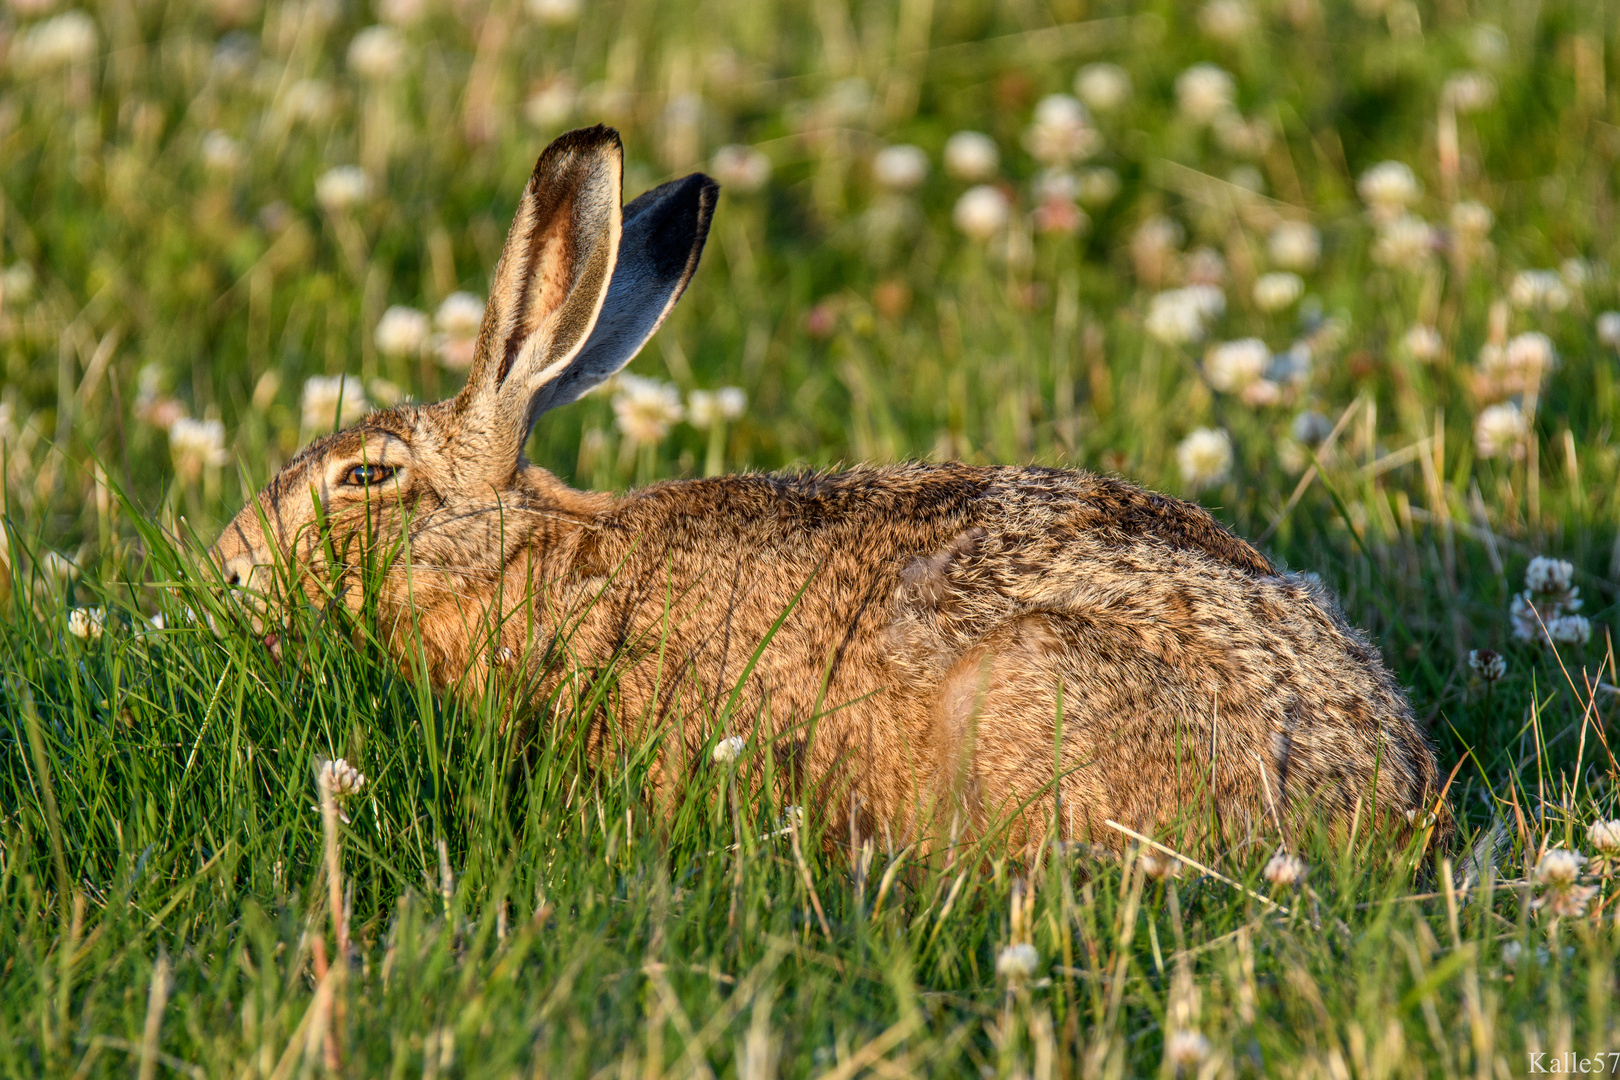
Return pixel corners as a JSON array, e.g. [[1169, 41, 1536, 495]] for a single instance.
[[533, 173, 719, 416]]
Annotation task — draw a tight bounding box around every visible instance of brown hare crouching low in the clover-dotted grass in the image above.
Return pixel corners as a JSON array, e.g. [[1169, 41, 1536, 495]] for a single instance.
[[214, 128, 1445, 847]]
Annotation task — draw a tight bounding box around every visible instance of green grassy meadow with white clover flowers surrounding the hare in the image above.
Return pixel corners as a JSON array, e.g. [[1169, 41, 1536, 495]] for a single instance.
[[0, 0, 1620, 1080]]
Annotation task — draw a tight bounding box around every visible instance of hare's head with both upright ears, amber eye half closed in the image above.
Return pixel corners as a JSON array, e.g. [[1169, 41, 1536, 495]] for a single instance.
[[212, 128, 719, 634]]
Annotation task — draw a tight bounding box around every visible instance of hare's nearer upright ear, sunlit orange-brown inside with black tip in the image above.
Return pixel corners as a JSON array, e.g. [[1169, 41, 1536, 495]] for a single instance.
[[457, 126, 624, 483]]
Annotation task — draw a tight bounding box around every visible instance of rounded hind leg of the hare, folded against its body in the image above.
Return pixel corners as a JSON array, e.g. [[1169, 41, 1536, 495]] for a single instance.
[[933, 612, 1296, 848]]
